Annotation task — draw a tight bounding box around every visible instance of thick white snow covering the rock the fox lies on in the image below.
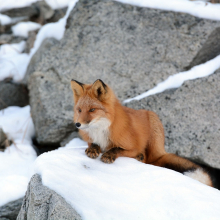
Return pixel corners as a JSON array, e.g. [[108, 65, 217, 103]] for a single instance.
[[35, 139, 220, 220]]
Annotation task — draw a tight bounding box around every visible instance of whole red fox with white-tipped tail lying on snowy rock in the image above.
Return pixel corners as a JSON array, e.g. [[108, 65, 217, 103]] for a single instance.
[[71, 79, 213, 186]]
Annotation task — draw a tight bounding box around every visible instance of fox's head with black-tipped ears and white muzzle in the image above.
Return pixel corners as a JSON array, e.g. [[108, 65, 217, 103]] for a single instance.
[[71, 79, 115, 130]]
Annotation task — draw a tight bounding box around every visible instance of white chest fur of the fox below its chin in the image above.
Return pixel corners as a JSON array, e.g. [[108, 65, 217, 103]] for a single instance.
[[86, 118, 111, 151]]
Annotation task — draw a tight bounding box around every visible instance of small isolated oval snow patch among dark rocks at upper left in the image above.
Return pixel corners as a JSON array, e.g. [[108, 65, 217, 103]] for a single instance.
[[11, 21, 41, 37]]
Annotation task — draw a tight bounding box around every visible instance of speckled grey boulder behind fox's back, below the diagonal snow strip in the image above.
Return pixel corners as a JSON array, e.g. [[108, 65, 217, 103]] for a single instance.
[[126, 69, 220, 168]]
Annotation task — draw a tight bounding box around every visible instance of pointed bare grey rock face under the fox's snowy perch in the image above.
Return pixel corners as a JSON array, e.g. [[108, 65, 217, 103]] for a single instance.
[[17, 174, 81, 220]]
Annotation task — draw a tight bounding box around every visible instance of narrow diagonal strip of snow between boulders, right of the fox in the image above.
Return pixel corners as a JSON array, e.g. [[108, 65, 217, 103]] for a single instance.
[[124, 55, 220, 103]]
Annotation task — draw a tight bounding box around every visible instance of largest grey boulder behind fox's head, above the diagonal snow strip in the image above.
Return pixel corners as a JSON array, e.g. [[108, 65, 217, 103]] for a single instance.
[[25, 0, 220, 143]]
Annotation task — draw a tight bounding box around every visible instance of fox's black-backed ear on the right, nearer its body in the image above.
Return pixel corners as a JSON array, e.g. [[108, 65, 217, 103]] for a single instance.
[[92, 79, 108, 101]]
